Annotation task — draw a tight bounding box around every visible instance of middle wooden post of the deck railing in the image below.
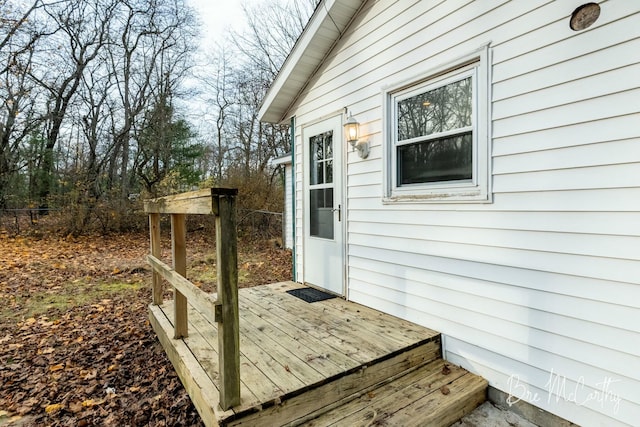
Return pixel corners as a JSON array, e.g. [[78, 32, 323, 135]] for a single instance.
[[171, 214, 189, 339]]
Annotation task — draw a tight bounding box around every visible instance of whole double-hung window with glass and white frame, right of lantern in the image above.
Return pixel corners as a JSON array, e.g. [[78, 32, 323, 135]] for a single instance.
[[384, 49, 490, 202]]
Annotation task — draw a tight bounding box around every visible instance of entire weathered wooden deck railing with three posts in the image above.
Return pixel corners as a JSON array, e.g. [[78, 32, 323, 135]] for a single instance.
[[144, 188, 240, 410]]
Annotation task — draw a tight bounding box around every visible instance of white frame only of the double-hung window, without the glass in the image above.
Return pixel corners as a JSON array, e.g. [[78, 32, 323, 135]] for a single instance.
[[383, 45, 492, 203]]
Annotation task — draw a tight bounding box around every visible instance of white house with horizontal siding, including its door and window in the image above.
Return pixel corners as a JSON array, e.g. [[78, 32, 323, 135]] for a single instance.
[[260, 0, 640, 426]]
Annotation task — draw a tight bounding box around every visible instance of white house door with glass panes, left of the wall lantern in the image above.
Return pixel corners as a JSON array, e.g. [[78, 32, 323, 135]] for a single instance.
[[302, 115, 344, 295]]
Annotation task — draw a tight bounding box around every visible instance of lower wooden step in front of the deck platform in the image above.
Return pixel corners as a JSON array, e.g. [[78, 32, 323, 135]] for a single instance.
[[299, 359, 487, 427]]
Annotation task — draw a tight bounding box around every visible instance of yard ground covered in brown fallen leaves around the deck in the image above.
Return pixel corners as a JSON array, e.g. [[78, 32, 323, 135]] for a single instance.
[[0, 231, 291, 426]]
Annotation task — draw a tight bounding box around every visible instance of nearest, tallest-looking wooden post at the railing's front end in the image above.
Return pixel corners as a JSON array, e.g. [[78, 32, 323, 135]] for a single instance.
[[212, 189, 240, 410]]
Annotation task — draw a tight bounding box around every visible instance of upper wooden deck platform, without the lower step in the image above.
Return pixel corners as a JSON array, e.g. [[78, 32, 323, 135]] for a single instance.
[[150, 282, 450, 425]]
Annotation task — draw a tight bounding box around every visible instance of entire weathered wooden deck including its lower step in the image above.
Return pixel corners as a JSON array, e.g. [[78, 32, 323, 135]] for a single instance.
[[149, 282, 486, 426]]
